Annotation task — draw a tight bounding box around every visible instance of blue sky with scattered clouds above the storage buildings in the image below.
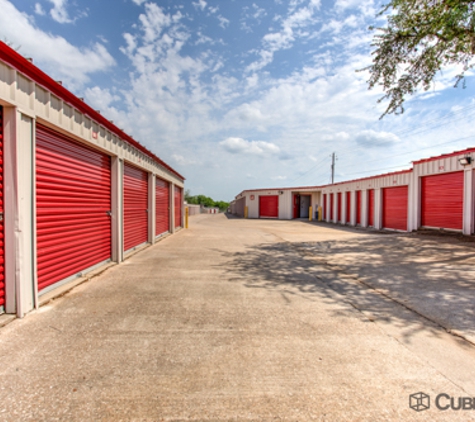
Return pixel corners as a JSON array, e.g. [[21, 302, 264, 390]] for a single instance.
[[0, 0, 475, 200]]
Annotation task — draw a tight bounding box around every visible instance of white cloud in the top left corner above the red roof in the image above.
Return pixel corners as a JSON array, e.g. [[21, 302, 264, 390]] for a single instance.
[[0, 0, 115, 88]]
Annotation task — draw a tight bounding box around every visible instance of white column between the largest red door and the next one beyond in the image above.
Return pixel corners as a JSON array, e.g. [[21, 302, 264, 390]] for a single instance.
[[111, 157, 124, 263]]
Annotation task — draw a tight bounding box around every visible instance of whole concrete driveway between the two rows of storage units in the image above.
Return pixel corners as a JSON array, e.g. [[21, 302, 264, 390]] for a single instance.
[[0, 215, 475, 421]]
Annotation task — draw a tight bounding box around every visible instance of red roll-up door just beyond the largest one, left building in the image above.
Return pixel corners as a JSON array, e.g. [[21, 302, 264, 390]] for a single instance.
[[124, 163, 148, 251]]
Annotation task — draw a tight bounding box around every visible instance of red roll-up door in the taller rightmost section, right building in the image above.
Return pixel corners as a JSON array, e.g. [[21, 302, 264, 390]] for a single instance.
[[421, 171, 463, 230]]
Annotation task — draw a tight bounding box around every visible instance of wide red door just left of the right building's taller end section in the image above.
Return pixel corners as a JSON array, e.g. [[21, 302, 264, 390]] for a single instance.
[[383, 186, 408, 231]]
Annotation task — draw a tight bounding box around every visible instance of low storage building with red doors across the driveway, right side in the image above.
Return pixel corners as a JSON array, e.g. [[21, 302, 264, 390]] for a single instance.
[[231, 148, 475, 235]]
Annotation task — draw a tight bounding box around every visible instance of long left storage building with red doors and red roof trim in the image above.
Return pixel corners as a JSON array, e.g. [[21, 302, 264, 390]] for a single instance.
[[0, 42, 185, 317]]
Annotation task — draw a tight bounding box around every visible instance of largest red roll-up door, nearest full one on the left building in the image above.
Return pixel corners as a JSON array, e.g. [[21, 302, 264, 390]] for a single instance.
[[36, 125, 111, 291]]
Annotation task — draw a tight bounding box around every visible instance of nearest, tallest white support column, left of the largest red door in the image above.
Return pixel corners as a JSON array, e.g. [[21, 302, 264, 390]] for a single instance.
[[4, 107, 34, 318]]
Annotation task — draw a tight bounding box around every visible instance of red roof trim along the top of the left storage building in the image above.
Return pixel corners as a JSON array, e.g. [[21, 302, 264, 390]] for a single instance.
[[0, 41, 185, 181]]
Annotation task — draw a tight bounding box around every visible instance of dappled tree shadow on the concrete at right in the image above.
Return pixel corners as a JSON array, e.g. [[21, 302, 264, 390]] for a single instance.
[[218, 235, 475, 342]]
